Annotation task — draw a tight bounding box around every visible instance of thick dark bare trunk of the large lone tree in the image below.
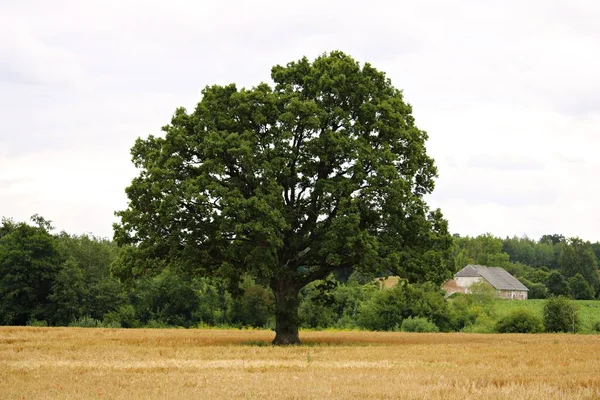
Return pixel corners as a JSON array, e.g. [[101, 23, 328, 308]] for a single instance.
[[273, 280, 300, 345]]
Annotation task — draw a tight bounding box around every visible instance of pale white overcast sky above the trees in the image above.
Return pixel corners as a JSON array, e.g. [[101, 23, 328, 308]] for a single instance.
[[0, 0, 600, 241]]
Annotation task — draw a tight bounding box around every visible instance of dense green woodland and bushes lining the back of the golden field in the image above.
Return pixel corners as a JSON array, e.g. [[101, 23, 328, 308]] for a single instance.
[[0, 215, 600, 332]]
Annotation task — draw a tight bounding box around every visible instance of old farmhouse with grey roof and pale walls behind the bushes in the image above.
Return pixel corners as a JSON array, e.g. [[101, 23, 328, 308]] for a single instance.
[[444, 265, 529, 300]]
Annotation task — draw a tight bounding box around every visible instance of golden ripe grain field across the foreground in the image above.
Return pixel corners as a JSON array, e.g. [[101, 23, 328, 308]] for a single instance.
[[0, 328, 600, 400]]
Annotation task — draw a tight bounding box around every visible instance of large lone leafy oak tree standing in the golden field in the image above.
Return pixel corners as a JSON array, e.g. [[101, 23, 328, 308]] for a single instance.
[[115, 51, 452, 344]]
